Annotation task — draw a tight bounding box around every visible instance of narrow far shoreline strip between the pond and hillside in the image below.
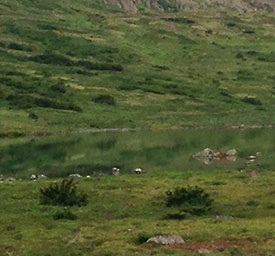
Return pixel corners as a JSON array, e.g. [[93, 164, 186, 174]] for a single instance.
[[0, 124, 275, 139]]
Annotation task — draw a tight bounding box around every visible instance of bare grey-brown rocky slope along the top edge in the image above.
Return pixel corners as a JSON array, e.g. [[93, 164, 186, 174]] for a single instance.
[[104, 0, 275, 12]]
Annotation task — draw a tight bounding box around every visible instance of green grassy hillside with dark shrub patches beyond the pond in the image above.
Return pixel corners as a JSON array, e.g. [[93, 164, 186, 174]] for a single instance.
[[0, 0, 275, 134]]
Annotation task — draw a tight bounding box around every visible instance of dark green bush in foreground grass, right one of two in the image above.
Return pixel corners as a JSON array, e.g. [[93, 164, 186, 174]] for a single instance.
[[166, 186, 213, 215]]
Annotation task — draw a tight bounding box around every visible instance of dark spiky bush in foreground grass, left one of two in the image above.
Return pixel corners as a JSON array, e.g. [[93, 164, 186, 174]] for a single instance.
[[40, 179, 88, 206]]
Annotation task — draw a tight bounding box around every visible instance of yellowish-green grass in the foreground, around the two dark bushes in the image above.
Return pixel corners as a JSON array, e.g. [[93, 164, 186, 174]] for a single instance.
[[0, 171, 275, 256]]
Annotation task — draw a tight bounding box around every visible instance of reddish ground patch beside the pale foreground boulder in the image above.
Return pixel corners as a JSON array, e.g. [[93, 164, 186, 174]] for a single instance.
[[167, 240, 257, 251]]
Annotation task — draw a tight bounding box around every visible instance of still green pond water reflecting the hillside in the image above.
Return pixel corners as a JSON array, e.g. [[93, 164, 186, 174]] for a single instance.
[[0, 129, 275, 179]]
